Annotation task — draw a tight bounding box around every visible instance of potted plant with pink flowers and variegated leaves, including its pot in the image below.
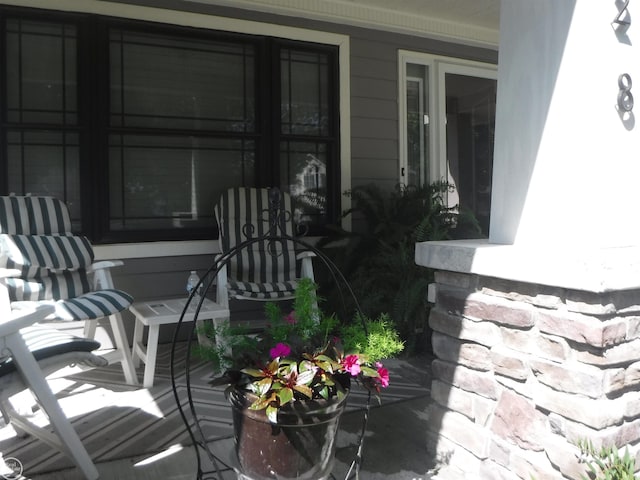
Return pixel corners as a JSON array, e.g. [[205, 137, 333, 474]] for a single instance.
[[197, 279, 404, 480]]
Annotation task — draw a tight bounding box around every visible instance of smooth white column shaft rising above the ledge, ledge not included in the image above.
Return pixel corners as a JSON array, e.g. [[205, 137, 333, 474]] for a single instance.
[[490, 0, 640, 247]]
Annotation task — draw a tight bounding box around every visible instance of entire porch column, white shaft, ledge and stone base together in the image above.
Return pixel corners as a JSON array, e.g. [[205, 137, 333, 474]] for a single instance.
[[416, 0, 640, 480]]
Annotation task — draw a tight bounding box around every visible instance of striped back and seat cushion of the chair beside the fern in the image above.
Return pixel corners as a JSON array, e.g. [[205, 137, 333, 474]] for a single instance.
[[215, 187, 298, 298]]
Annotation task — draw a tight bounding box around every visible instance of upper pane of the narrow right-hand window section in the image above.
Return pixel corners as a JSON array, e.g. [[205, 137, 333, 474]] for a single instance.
[[280, 49, 331, 135]]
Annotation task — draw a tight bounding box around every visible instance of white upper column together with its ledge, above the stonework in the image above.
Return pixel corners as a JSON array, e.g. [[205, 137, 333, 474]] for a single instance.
[[416, 0, 640, 292]]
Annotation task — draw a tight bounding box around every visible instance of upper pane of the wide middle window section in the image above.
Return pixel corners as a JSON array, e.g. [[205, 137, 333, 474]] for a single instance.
[[110, 30, 256, 132]]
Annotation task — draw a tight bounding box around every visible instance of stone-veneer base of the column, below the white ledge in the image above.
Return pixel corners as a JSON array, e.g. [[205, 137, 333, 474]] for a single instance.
[[428, 271, 640, 480]]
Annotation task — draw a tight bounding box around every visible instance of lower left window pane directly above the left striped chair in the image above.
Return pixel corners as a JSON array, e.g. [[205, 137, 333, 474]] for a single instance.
[[7, 131, 81, 231]]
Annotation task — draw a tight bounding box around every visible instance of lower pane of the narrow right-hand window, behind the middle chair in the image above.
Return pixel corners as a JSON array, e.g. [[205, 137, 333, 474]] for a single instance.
[[280, 142, 327, 225]]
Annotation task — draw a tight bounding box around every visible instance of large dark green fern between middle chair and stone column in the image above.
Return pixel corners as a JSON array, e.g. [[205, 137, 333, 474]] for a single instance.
[[320, 181, 481, 352]]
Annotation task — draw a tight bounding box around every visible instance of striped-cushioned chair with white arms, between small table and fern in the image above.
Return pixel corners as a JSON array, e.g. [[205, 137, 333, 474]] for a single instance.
[[215, 187, 314, 308]]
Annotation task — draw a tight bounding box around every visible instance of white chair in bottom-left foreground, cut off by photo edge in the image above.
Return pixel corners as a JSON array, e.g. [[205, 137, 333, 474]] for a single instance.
[[0, 304, 107, 480]]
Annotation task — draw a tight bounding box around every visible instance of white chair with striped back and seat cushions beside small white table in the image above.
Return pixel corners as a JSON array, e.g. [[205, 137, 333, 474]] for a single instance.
[[0, 195, 138, 385]]
